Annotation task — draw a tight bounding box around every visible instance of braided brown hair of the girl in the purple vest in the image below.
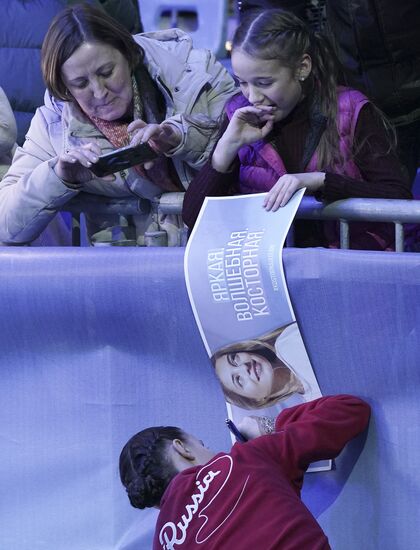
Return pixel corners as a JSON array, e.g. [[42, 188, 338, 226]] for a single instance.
[[232, 9, 343, 170]]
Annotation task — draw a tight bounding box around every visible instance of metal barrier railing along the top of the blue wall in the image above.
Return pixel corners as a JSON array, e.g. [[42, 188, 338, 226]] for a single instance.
[[63, 193, 420, 252]]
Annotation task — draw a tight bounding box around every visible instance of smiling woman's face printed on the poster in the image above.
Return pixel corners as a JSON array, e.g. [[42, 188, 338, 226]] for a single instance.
[[215, 351, 274, 399]]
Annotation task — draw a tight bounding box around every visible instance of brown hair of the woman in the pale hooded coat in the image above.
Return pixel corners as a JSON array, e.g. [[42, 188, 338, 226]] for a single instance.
[[41, 4, 144, 101]]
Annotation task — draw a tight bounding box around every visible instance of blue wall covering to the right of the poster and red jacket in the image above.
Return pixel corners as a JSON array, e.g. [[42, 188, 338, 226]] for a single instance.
[[285, 249, 420, 550]]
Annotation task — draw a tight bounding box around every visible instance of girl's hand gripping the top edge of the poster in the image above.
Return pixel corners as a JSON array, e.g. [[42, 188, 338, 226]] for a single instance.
[[263, 172, 325, 212]]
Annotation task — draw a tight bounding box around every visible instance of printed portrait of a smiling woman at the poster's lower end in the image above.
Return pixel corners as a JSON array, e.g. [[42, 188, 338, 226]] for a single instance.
[[211, 323, 321, 409]]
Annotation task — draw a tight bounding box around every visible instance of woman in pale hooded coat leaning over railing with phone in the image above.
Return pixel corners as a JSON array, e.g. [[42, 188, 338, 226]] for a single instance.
[[0, 5, 234, 244]]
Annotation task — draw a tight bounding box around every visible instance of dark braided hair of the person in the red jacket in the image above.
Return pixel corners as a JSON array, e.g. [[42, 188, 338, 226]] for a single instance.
[[120, 426, 185, 509]]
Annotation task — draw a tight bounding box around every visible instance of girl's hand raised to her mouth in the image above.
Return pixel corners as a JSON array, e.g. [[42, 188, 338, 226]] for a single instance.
[[212, 105, 274, 172]]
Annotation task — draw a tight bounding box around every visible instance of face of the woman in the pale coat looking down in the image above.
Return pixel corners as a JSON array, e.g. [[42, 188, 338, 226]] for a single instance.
[[61, 42, 133, 120]]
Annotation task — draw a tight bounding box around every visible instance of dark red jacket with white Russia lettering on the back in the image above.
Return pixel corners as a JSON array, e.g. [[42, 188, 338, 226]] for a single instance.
[[153, 395, 370, 550]]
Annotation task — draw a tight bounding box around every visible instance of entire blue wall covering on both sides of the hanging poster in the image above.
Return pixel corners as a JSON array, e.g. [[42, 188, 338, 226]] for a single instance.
[[0, 247, 420, 550]]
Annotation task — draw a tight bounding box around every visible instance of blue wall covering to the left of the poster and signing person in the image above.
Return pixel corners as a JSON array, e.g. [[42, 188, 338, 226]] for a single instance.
[[0, 248, 230, 550]]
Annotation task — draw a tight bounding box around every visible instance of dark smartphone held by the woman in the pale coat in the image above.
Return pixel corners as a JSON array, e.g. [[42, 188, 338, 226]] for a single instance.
[[89, 143, 158, 178]]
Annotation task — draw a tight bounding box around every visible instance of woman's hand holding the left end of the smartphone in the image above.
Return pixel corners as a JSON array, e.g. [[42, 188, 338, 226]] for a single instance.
[[54, 143, 106, 184]]
